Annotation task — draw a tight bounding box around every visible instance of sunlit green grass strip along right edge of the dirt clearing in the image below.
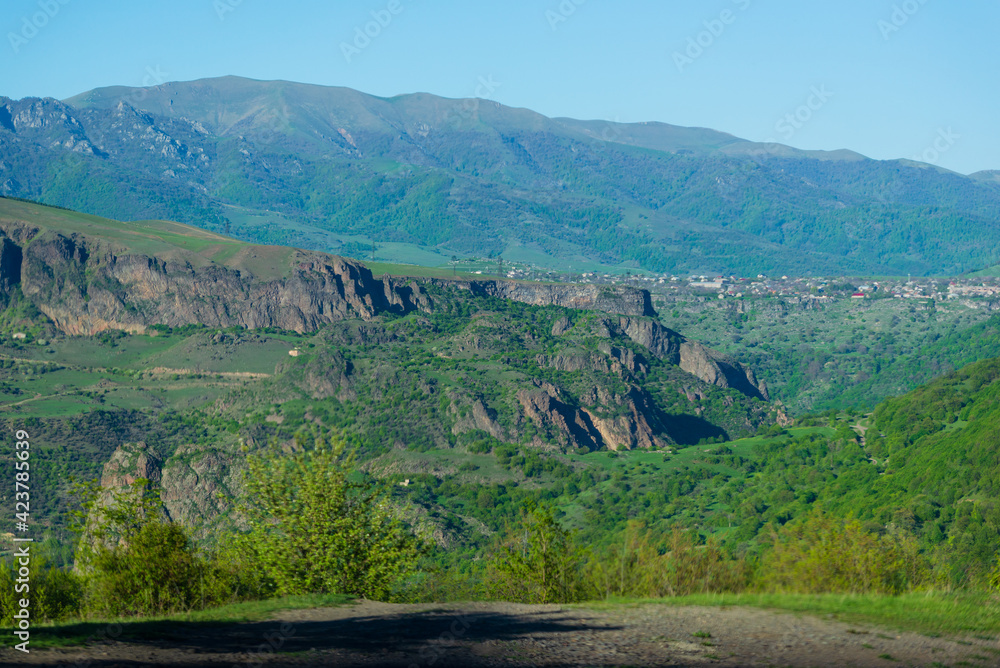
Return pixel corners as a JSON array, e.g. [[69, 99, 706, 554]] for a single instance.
[[580, 592, 1000, 638]]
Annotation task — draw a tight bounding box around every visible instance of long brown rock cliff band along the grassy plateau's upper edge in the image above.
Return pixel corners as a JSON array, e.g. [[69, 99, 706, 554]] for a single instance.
[[0, 221, 655, 335]]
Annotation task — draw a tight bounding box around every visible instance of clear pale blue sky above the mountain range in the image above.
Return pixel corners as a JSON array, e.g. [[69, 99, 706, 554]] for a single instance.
[[0, 0, 1000, 173]]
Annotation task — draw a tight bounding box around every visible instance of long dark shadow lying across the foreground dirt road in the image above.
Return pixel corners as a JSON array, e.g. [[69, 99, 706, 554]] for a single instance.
[[15, 607, 656, 668]]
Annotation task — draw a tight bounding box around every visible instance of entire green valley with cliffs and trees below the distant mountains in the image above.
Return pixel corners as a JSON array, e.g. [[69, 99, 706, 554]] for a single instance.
[[0, 190, 1000, 660]]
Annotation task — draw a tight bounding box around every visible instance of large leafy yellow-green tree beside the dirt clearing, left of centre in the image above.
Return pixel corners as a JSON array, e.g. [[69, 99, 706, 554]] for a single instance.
[[243, 437, 424, 600]]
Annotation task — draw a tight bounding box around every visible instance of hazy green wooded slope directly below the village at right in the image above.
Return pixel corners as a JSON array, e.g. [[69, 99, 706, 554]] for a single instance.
[[653, 292, 1000, 414]]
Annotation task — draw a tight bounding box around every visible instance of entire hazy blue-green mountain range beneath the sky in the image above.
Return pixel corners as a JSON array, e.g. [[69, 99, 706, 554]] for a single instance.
[[0, 77, 1000, 275]]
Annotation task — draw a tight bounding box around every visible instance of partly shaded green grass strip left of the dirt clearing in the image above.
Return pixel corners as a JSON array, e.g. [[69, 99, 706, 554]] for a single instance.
[[16, 594, 353, 649]]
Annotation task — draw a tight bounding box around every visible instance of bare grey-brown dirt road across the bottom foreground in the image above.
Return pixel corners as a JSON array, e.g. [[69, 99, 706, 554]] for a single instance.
[[0, 601, 1000, 668]]
